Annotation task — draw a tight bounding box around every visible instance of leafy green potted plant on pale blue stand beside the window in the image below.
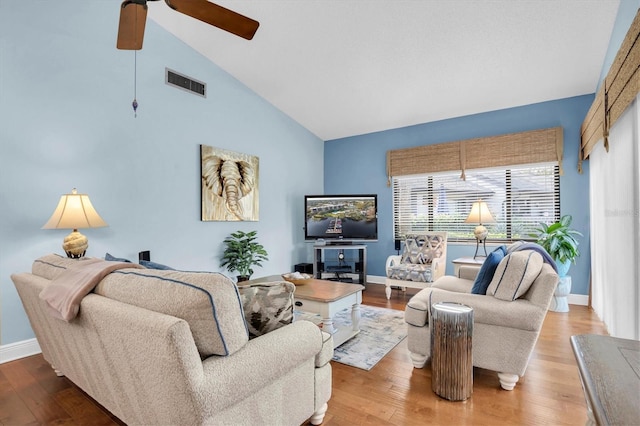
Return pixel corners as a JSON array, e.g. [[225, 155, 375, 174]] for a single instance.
[[530, 215, 582, 277]]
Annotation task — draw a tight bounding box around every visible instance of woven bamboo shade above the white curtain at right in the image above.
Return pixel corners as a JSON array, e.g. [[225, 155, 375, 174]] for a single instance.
[[578, 9, 640, 172]]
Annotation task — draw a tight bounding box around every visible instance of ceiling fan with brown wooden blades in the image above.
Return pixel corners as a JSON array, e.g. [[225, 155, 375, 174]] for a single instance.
[[116, 0, 260, 50]]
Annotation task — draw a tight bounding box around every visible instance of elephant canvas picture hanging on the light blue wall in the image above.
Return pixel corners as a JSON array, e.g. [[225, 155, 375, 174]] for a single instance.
[[200, 145, 259, 221]]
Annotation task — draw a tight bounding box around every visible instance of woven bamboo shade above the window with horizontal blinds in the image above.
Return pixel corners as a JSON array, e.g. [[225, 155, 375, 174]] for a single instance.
[[387, 127, 563, 184]]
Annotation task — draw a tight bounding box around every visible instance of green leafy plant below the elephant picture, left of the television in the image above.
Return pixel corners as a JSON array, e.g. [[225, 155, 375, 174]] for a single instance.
[[220, 231, 269, 281]]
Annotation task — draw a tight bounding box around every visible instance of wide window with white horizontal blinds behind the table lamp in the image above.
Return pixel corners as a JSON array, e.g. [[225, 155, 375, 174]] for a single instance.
[[393, 163, 560, 242]]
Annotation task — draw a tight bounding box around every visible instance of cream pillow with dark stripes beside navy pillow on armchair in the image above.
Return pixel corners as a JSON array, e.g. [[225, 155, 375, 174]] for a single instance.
[[487, 250, 544, 301]]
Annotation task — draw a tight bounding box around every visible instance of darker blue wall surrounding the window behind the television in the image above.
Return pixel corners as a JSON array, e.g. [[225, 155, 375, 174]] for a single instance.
[[324, 95, 594, 294]]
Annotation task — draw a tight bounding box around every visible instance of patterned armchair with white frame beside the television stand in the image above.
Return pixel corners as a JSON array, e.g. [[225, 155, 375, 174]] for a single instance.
[[385, 232, 447, 299]]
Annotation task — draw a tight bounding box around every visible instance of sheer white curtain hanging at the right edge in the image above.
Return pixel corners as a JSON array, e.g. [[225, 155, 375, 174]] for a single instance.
[[589, 97, 640, 340]]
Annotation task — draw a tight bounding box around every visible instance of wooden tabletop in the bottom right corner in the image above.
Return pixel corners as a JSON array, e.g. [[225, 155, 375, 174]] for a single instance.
[[571, 334, 640, 426]]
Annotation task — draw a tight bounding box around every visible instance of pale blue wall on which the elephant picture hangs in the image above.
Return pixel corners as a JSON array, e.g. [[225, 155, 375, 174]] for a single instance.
[[0, 0, 323, 345]]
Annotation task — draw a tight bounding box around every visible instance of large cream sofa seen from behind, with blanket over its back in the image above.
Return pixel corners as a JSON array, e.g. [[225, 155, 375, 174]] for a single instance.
[[12, 255, 333, 425]]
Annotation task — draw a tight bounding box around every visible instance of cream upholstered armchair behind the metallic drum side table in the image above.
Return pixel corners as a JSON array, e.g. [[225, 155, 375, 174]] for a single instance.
[[405, 250, 558, 390]]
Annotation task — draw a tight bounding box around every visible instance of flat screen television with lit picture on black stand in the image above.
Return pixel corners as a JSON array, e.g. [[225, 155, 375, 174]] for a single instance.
[[304, 194, 378, 244]]
